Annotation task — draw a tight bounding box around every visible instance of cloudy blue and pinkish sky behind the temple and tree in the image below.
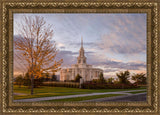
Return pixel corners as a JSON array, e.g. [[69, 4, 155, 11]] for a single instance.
[[14, 13, 146, 77]]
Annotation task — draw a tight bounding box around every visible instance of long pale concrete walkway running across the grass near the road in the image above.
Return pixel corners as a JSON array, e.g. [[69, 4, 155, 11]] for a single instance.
[[13, 89, 146, 102]]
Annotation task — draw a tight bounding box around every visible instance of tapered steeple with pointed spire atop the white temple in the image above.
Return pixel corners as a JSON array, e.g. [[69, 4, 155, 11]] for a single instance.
[[77, 37, 86, 64]]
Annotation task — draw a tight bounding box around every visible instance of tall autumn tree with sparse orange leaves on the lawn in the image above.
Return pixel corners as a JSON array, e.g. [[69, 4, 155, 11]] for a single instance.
[[14, 16, 63, 95]]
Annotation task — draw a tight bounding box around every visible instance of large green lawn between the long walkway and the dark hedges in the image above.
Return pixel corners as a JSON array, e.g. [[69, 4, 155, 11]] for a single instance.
[[13, 85, 146, 99]]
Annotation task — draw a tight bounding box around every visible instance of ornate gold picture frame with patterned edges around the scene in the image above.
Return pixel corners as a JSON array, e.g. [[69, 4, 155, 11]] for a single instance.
[[0, 0, 160, 114]]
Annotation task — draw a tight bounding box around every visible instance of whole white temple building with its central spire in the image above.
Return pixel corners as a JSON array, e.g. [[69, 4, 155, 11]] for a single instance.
[[60, 38, 103, 81]]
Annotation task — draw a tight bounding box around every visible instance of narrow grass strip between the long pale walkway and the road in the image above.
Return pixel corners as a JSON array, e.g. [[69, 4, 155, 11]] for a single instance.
[[45, 94, 123, 102]]
